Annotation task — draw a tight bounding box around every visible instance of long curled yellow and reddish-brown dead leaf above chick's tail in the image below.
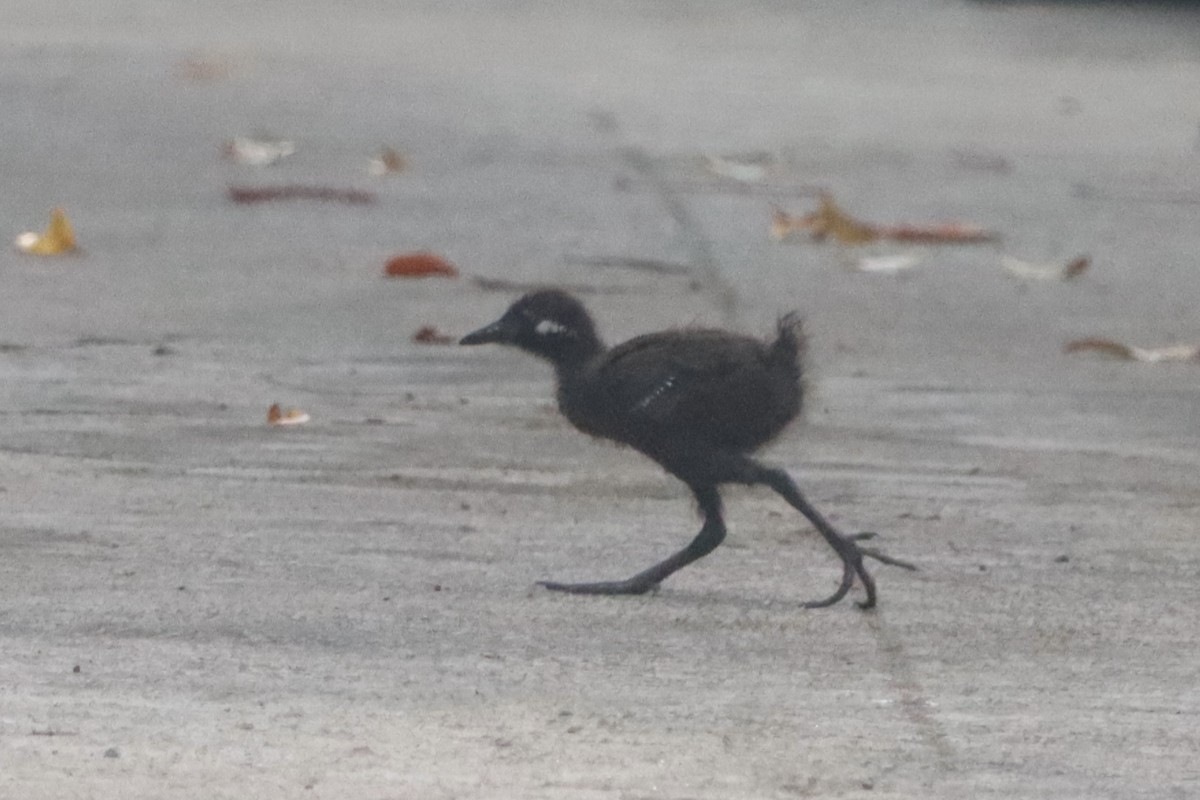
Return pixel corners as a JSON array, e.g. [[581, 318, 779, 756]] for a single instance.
[[770, 193, 998, 245]]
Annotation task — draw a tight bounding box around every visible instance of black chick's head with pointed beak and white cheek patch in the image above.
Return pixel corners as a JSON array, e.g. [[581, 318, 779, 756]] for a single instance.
[[458, 289, 604, 366]]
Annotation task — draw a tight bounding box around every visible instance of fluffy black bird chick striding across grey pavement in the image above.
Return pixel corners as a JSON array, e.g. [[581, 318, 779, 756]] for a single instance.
[[461, 289, 916, 608]]
